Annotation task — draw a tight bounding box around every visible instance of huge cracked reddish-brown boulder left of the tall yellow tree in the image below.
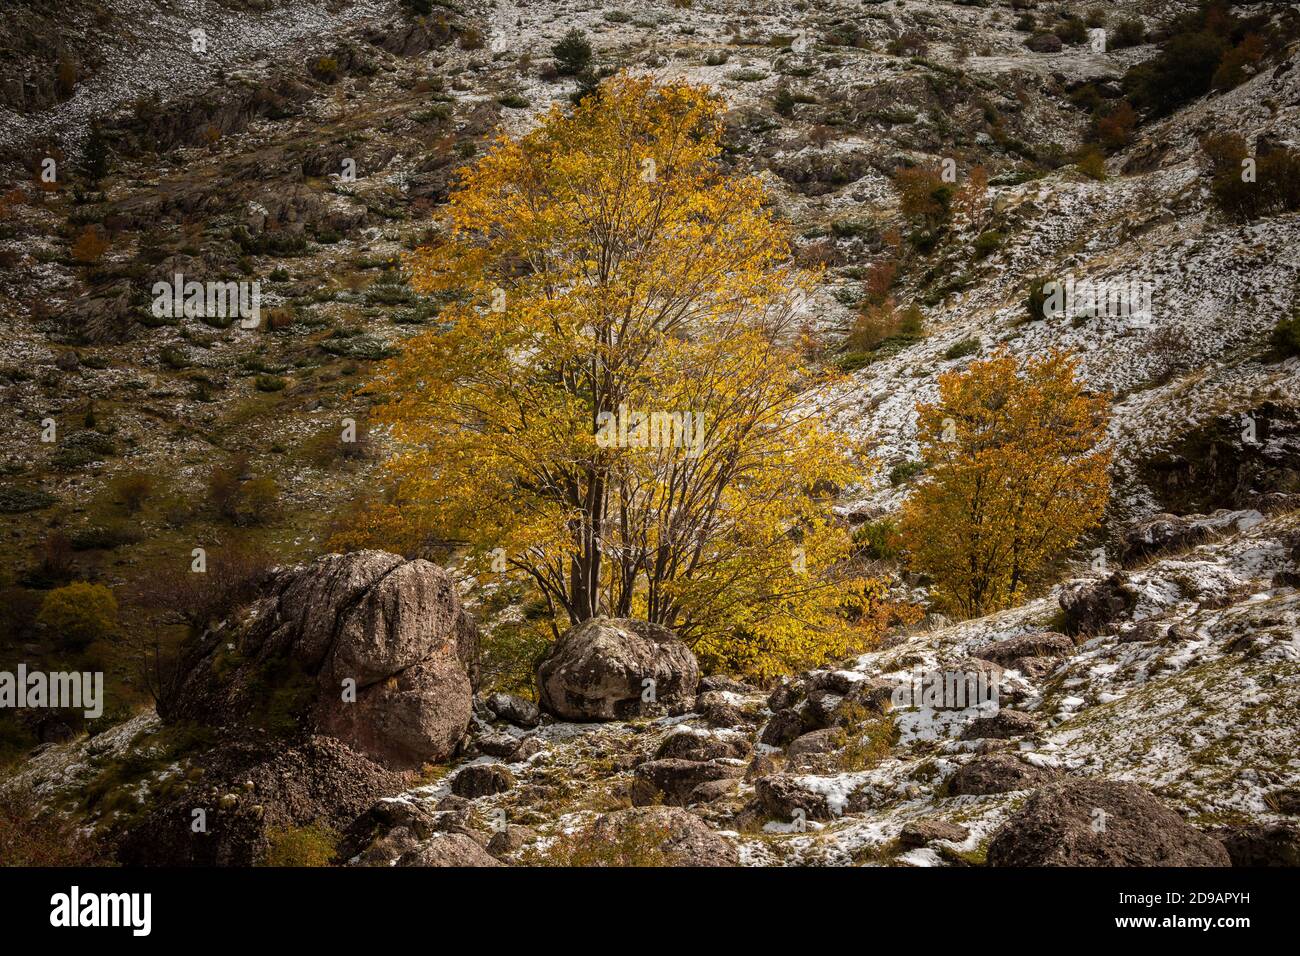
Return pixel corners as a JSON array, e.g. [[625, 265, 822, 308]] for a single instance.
[[173, 551, 477, 770]]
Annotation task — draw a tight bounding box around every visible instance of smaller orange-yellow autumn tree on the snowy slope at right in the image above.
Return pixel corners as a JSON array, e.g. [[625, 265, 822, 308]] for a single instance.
[[901, 350, 1110, 617]]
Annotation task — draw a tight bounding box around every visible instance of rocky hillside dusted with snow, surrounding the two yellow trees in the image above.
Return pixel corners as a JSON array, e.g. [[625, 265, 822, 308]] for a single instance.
[[0, 0, 1300, 865]]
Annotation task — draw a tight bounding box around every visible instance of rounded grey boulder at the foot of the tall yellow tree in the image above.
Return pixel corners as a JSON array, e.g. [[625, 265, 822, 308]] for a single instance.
[[537, 618, 699, 721]]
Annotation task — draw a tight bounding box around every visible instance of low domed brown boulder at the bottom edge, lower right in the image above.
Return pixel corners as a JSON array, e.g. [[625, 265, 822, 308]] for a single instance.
[[988, 780, 1230, 866]]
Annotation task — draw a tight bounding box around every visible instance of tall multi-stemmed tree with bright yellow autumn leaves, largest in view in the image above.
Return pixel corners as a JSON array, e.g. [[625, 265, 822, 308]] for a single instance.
[[345, 75, 904, 675]]
